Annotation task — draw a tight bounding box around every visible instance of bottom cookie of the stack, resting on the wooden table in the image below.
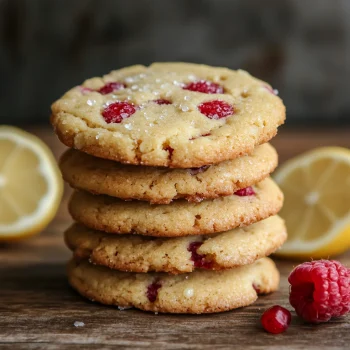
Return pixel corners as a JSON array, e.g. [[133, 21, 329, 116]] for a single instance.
[[68, 258, 279, 314]]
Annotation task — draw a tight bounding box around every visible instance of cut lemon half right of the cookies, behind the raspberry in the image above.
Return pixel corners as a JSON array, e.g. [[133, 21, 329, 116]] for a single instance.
[[275, 147, 350, 259]]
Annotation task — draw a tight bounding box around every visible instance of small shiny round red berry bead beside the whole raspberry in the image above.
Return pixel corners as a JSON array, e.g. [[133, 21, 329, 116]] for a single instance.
[[261, 305, 292, 334]]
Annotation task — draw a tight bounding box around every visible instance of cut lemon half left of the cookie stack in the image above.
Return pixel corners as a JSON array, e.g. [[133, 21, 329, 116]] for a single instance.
[[0, 126, 63, 241]]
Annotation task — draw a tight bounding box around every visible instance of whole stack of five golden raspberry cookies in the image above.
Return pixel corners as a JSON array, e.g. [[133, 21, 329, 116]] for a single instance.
[[51, 63, 286, 313]]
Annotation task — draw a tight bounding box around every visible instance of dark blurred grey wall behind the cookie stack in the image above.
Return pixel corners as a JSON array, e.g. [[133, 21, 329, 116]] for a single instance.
[[0, 0, 350, 125]]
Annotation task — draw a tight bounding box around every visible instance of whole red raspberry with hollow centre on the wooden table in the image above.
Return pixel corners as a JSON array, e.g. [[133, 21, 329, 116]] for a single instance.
[[288, 260, 350, 323]]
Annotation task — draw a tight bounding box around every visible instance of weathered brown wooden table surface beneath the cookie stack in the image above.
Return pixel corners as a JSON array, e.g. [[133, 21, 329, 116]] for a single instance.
[[0, 128, 350, 350]]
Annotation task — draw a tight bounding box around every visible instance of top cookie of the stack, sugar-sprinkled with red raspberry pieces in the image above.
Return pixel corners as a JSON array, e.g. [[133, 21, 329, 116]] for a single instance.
[[51, 63, 285, 168]]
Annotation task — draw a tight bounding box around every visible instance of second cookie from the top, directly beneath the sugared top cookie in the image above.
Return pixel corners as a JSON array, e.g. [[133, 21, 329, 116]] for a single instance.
[[60, 144, 278, 204]]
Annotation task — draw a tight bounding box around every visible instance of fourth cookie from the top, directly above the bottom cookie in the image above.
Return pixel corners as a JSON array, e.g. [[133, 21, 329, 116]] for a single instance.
[[65, 216, 287, 274]]
